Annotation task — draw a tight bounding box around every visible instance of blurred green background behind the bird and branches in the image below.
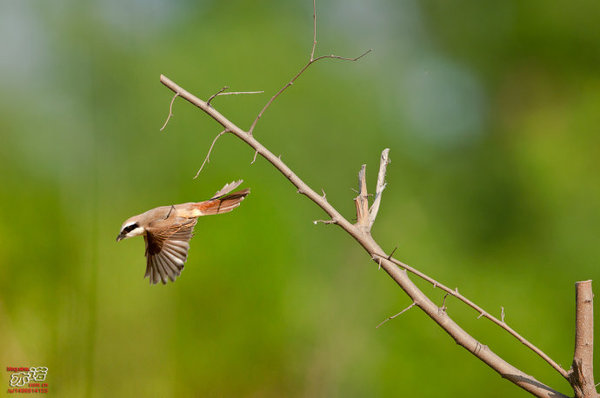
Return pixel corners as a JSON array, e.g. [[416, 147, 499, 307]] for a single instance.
[[0, 0, 600, 397]]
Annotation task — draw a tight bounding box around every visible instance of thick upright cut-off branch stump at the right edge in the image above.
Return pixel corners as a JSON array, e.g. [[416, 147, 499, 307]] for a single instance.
[[569, 280, 598, 398]]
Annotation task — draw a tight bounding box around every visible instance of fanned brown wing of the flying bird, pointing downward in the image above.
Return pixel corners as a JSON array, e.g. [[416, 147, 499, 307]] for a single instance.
[[144, 218, 197, 284]]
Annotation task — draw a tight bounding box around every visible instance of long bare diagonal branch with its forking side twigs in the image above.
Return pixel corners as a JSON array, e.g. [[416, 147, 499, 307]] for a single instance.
[[155, 0, 566, 398]]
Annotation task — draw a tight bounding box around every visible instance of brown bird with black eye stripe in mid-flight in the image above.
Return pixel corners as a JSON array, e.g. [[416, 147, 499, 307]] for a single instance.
[[117, 180, 250, 285]]
